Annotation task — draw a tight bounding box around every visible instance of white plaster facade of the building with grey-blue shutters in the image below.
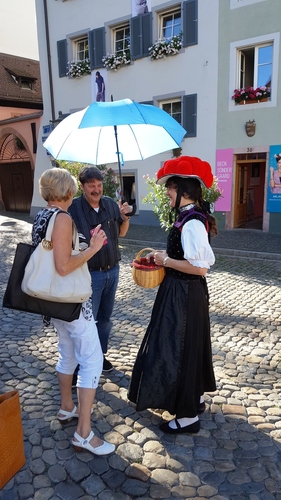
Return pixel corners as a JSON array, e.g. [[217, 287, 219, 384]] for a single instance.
[[32, 0, 219, 216]]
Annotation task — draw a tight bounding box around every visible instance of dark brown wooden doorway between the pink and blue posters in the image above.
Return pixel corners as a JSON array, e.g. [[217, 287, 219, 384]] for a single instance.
[[233, 153, 266, 229]]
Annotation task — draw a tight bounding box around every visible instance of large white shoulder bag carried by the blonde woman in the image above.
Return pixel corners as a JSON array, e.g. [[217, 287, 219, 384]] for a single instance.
[[21, 212, 92, 303]]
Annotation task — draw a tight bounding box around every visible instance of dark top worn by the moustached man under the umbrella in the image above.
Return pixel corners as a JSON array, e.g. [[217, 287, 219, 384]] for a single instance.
[[68, 195, 123, 271]]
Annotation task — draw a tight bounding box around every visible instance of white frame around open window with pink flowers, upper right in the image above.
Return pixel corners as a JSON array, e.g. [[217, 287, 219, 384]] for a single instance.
[[229, 32, 280, 111]]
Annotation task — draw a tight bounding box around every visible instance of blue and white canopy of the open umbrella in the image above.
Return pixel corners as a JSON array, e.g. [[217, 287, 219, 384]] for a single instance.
[[44, 99, 186, 165]]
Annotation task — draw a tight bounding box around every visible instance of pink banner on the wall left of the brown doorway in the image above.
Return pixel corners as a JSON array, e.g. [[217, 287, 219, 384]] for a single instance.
[[215, 149, 233, 212]]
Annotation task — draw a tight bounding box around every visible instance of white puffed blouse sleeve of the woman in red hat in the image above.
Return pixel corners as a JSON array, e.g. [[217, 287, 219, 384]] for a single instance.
[[181, 219, 215, 269]]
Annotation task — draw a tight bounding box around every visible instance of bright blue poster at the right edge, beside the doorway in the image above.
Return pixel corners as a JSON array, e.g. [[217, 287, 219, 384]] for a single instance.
[[266, 145, 281, 212]]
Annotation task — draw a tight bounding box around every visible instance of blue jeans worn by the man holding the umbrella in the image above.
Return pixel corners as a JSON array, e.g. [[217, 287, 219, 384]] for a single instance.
[[90, 264, 119, 354]]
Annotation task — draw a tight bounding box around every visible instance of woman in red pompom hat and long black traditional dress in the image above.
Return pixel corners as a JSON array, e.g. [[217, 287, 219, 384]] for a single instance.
[[128, 156, 217, 434]]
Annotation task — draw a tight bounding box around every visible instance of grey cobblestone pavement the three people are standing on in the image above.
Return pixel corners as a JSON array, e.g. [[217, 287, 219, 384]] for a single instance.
[[0, 215, 281, 500]]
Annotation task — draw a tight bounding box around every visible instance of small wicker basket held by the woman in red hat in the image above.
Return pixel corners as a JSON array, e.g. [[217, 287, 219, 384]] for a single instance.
[[131, 248, 165, 288]]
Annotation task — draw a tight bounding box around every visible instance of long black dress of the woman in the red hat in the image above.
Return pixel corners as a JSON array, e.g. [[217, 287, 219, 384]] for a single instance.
[[128, 211, 216, 418]]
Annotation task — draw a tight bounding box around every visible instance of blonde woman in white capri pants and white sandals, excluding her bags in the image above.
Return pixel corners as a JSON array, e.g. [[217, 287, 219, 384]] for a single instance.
[[32, 168, 115, 455]]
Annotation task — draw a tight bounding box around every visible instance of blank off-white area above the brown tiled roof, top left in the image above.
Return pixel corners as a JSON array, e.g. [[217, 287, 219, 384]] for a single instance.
[[0, 0, 39, 61]]
